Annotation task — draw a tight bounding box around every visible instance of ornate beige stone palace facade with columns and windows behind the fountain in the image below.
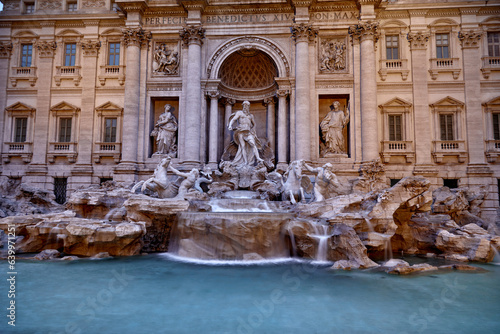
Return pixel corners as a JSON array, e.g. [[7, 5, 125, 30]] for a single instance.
[[0, 0, 500, 217]]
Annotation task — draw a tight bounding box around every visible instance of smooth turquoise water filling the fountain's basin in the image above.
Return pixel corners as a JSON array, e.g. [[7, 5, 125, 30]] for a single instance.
[[0, 254, 500, 334]]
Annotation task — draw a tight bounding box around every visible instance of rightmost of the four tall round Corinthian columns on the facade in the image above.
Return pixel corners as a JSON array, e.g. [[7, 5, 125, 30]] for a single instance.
[[349, 21, 379, 161]]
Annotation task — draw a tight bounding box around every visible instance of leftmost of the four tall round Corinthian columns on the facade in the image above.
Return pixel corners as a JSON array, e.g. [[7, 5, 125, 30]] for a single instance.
[[121, 27, 151, 166]]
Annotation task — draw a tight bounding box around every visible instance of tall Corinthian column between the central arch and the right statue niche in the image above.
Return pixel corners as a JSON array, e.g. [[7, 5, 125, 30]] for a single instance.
[[291, 23, 318, 161]]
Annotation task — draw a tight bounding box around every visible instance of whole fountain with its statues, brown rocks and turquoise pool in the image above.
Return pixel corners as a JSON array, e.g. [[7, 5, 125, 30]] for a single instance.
[[0, 101, 500, 333]]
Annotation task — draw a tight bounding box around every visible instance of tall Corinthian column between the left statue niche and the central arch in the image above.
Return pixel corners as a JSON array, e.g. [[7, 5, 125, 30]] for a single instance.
[[180, 25, 205, 164]]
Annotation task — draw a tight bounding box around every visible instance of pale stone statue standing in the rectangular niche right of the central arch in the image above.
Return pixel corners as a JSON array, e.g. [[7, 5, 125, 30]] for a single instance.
[[320, 101, 349, 156]]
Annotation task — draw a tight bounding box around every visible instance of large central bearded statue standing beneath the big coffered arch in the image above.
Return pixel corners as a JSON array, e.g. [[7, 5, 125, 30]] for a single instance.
[[227, 101, 264, 165]]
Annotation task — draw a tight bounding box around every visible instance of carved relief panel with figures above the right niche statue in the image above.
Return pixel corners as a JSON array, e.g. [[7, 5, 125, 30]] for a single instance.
[[319, 39, 347, 73]]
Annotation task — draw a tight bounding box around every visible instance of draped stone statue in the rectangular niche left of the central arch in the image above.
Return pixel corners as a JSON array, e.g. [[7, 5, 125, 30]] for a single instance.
[[151, 104, 177, 157]]
